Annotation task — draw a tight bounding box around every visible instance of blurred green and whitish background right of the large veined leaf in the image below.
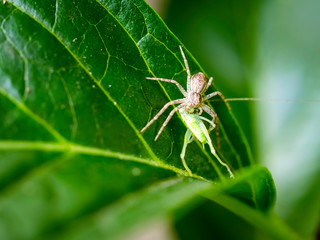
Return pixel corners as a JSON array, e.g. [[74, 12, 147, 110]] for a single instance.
[[148, 0, 320, 237]]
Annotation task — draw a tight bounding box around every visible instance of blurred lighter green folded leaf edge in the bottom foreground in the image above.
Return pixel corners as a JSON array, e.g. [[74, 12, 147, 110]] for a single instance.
[[46, 167, 278, 239]]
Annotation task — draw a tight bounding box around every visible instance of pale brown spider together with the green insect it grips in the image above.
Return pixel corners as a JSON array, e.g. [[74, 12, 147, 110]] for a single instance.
[[140, 46, 233, 178]]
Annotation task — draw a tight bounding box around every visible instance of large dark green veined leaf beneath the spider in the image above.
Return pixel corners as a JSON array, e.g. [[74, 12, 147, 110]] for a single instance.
[[0, 0, 275, 239]]
